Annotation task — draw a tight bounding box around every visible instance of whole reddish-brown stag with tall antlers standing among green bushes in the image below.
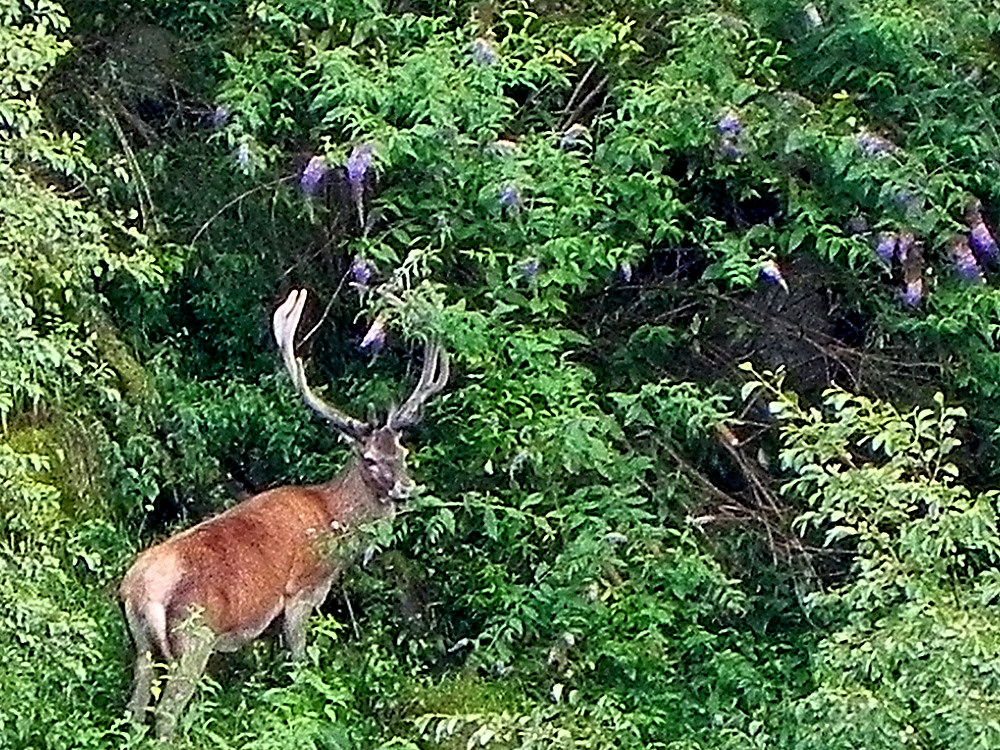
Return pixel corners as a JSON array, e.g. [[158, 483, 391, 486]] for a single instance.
[[119, 290, 449, 739]]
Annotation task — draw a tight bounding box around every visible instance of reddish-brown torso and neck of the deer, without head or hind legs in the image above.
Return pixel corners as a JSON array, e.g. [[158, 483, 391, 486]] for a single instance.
[[121, 465, 393, 660]]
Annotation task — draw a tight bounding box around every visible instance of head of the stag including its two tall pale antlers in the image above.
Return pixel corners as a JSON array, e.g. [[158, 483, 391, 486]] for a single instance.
[[274, 289, 448, 500]]
